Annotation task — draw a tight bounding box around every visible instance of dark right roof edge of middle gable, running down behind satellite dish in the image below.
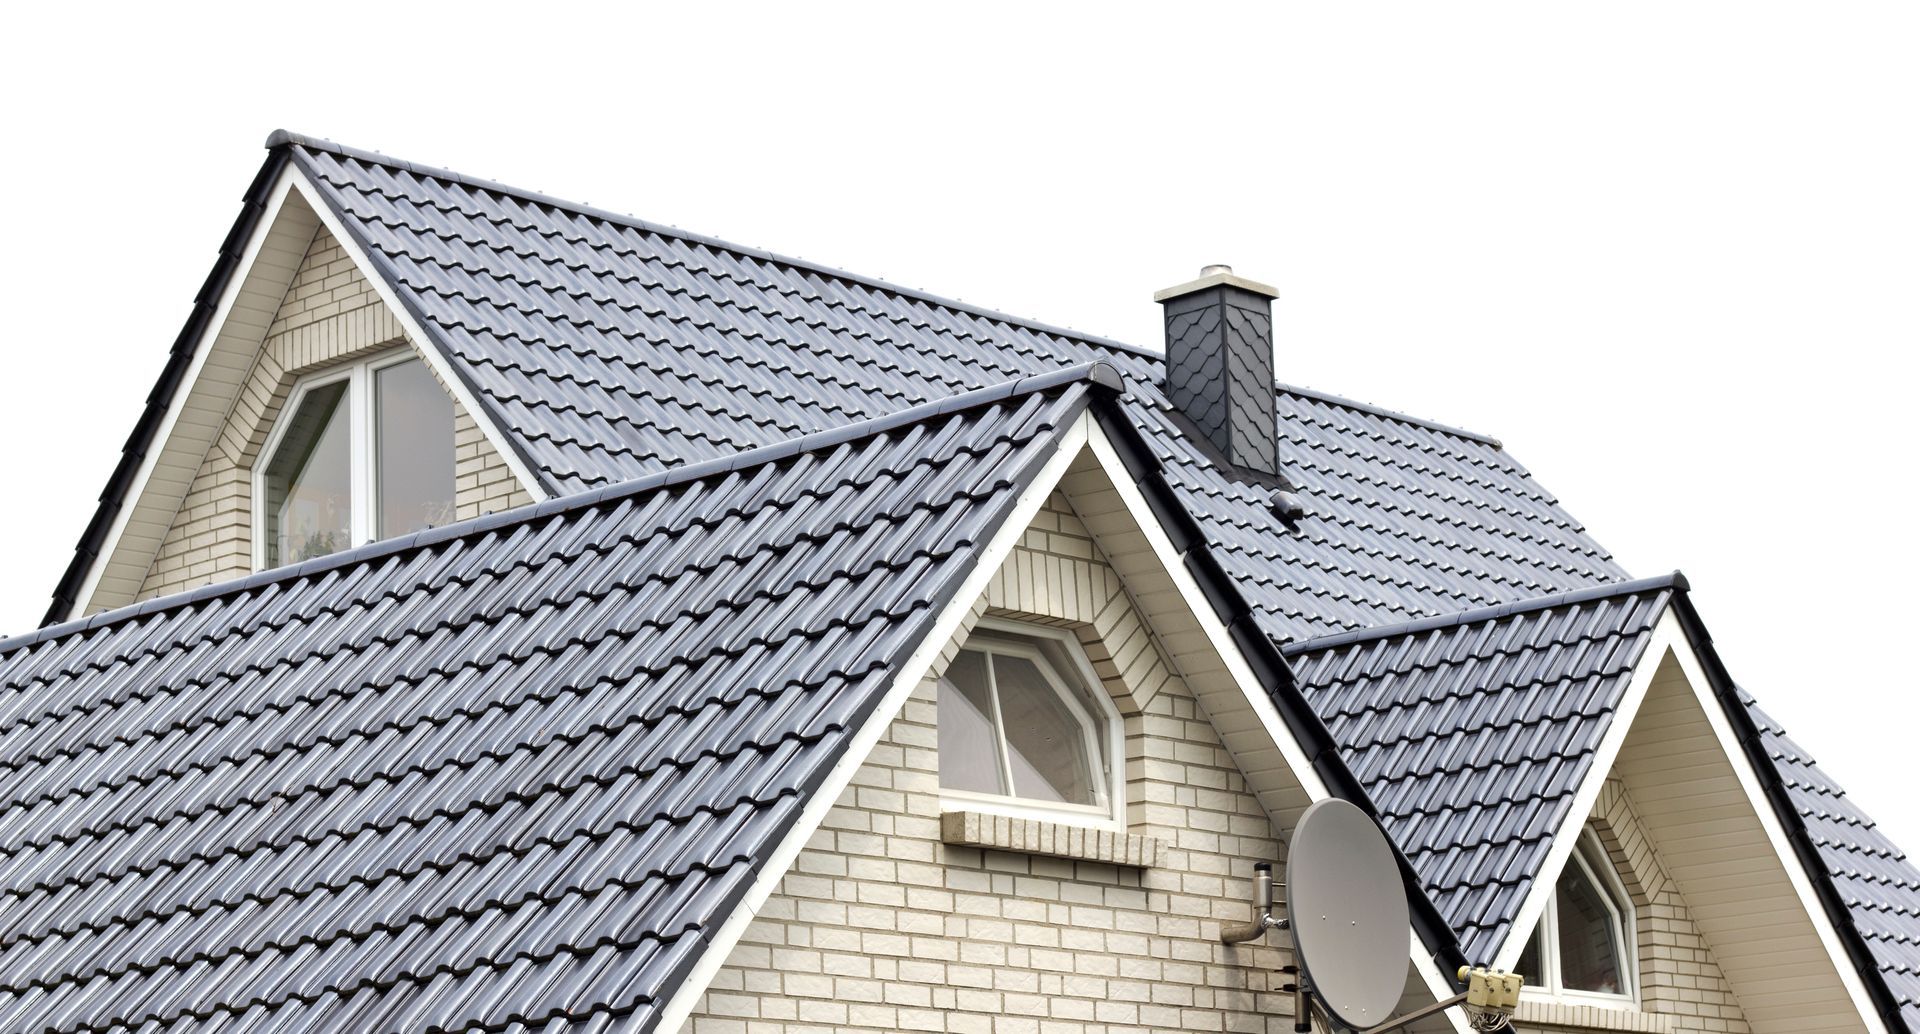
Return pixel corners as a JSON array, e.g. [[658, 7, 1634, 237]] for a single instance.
[[1094, 395, 1469, 986]]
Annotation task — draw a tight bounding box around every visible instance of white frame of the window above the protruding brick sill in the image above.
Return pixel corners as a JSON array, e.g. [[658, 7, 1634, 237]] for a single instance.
[[941, 618, 1127, 833]]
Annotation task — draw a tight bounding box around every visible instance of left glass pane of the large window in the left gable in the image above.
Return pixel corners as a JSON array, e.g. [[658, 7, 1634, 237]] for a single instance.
[[267, 382, 353, 568]]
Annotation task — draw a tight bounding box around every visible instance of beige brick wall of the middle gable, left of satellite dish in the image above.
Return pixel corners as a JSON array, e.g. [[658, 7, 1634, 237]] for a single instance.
[[687, 497, 1290, 1034]]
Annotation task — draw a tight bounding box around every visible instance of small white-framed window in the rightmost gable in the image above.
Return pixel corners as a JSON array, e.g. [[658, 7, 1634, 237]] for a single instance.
[[1515, 831, 1634, 999]]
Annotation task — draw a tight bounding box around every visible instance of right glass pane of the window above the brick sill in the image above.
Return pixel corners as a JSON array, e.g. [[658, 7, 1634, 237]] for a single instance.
[[993, 656, 1098, 806]]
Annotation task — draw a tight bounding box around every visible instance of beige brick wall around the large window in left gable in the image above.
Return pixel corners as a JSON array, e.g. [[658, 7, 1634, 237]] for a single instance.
[[138, 228, 532, 599]]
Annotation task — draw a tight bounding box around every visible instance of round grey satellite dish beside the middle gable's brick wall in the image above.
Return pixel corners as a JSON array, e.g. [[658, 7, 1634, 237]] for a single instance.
[[1286, 798, 1407, 1030]]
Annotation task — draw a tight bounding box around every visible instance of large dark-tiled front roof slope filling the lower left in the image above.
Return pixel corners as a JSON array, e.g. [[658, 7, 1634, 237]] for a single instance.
[[0, 366, 1114, 1032]]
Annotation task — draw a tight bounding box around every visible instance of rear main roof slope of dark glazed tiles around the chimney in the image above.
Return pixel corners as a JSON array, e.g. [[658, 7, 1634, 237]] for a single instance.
[[56, 132, 1626, 641]]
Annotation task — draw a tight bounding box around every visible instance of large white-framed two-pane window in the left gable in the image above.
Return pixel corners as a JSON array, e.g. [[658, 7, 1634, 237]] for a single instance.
[[253, 351, 453, 568]]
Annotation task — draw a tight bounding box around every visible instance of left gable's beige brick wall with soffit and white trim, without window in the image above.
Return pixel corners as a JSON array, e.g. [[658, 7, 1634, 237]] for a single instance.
[[69, 173, 532, 614]]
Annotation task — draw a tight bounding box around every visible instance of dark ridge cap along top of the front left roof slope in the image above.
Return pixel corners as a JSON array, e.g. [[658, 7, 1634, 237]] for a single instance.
[[0, 361, 1125, 656]]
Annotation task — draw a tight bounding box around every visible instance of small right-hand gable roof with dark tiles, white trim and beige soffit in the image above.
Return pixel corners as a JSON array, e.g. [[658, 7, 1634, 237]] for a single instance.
[[1288, 587, 1884, 1032]]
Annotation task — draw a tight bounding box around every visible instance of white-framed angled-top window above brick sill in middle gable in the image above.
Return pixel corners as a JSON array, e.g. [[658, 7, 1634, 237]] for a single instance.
[[935, 622, 1121, 819]]
